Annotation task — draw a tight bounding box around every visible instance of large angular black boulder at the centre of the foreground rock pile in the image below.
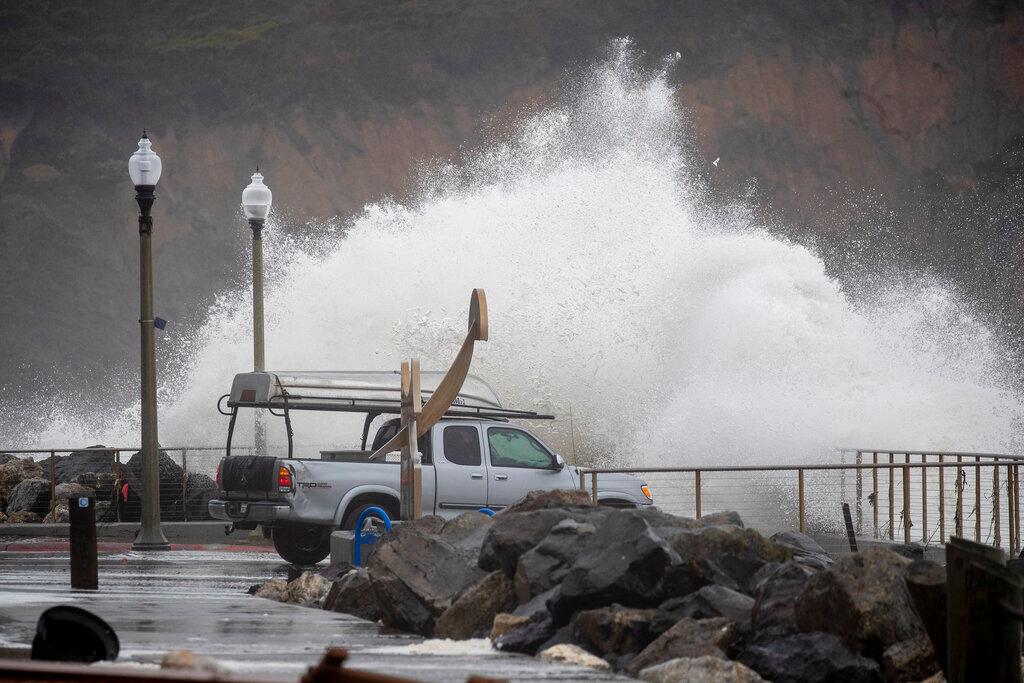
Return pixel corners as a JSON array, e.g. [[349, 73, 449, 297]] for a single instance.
[[551, 510, 684, 624]]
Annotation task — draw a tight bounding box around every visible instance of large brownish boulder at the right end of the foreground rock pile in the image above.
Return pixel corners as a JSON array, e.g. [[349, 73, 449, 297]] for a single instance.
[[796, 547, 925, 659]]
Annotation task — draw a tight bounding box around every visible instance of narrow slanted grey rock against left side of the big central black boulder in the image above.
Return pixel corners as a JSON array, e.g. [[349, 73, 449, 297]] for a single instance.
[[515, 519, 596, 603]]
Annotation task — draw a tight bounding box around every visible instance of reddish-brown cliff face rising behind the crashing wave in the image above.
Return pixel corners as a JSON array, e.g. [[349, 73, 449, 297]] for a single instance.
[[0, 0, 1024, 386]]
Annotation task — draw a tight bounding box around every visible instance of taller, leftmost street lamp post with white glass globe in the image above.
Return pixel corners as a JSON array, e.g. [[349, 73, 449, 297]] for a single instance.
[[128, 130, 171, 550]]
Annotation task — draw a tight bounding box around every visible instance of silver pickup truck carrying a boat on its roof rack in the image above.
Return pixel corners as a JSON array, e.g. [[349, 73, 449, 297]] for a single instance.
[[209, 372, 652, 564]]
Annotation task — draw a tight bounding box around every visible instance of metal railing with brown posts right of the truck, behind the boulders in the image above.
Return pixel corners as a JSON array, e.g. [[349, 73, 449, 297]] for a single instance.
[[581, 449, 1024, 554]]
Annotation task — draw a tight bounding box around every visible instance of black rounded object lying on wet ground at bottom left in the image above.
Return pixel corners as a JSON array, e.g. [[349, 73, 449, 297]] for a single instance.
[[32, 605, 121, 661]]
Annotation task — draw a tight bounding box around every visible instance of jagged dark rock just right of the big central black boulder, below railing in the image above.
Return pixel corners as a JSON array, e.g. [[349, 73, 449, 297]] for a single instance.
[[665, 525, 791, 596]]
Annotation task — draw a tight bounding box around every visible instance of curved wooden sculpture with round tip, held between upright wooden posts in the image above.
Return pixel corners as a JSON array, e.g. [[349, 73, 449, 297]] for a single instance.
[[370, 289, 487, 519]]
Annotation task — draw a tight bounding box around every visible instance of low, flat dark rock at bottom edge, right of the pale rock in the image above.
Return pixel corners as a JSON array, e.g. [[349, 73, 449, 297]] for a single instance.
[[735, 633, 882, 683]]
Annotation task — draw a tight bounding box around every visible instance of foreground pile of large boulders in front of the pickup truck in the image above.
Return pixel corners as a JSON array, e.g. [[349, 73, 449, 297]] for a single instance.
[[256, 492, 938, 681]]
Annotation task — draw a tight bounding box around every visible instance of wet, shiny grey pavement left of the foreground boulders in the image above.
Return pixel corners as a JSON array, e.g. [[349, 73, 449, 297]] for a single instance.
[[0, 551, 625, 681]]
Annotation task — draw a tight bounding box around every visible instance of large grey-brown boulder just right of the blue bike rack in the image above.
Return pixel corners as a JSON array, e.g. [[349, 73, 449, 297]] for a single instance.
[[367, 513, 484, 637]]
